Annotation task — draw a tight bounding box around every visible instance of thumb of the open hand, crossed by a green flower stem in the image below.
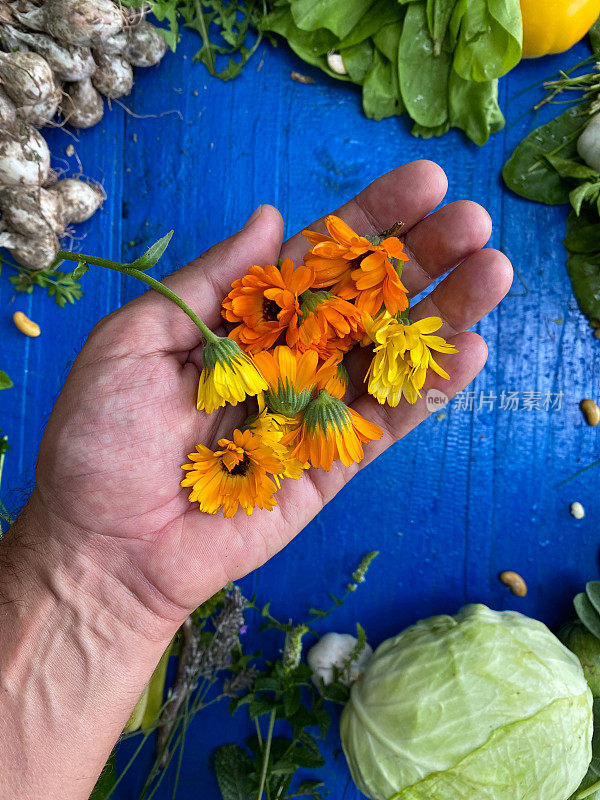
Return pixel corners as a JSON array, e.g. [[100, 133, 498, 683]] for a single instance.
[[130, 205, 283, 351]]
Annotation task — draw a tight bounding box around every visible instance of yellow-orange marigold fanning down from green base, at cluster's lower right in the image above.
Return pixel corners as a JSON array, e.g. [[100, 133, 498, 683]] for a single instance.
[[281, 389, 382, 471]]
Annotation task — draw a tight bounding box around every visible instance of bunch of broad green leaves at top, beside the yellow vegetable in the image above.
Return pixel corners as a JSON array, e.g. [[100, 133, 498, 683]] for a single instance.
[[262, 0, 521, 144]]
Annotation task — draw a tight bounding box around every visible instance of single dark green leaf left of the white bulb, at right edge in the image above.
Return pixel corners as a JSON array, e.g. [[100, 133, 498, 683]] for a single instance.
[[502, 106, 585, 205]]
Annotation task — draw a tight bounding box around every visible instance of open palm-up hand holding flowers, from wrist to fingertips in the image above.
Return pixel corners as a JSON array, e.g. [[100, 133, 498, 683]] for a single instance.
[[25, 161, 512, 628]]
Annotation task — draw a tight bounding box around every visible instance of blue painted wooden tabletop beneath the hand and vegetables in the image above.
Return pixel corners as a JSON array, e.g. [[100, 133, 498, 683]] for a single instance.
[[0, 28, 600, 800]]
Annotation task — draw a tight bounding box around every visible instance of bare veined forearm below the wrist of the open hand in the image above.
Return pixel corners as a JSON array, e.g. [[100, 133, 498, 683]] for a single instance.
[[0, 500, 176, 800]]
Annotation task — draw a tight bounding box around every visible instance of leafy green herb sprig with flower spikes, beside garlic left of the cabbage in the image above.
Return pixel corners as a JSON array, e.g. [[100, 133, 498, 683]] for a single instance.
[[214, 552, 378, 800]]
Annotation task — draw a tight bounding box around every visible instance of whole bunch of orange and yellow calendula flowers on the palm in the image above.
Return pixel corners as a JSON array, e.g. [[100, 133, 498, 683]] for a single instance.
[[181, 216, 456, 517]]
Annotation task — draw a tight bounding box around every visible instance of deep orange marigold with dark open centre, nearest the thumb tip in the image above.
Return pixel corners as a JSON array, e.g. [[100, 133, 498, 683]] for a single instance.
[[221, 258, 314, 353]]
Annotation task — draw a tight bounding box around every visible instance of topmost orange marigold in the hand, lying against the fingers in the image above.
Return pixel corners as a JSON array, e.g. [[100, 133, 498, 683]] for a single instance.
[[303, 214, 409, 316]]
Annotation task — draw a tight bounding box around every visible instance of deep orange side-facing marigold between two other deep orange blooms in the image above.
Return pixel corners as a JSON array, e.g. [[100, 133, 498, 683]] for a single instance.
[[286, 291, 364, 360]]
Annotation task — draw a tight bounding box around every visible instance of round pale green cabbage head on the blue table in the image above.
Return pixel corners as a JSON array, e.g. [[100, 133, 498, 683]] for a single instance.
[[341, 605, 593, 800]]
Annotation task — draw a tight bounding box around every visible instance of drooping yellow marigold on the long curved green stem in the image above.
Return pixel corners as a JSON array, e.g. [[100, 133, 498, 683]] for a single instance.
[[196, 336, 267, 414]]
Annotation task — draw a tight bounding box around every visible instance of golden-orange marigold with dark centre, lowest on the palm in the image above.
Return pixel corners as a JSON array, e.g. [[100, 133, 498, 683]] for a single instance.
[[181, 429, 281, 517]]
